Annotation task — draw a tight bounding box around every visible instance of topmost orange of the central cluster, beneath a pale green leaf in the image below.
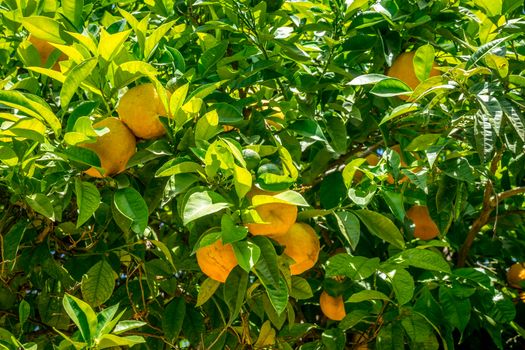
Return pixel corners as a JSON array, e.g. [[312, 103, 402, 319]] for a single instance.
[[246, 203, 297, 236]]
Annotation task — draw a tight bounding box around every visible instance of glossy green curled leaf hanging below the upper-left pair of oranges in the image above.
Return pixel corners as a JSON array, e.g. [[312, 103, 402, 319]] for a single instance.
[[113, 187, 149, 234]]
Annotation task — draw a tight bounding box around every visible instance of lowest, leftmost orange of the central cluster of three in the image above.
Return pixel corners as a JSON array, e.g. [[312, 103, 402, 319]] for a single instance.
[[197, 239, 238, 283]]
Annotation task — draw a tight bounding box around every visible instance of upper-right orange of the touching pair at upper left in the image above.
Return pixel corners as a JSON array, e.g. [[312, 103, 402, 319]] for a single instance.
[[117, 83, 169, 139]]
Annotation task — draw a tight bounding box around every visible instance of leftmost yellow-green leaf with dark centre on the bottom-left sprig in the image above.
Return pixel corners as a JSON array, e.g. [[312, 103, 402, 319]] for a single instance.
[[62, 293, 97, 344]]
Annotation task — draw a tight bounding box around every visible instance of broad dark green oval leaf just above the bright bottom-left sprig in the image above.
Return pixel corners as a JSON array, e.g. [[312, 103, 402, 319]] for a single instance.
[[81, 260, 115, 307]]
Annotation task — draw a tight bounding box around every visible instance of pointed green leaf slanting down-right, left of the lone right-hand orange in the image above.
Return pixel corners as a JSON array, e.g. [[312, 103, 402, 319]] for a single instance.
[[353, 209, 405, 249]]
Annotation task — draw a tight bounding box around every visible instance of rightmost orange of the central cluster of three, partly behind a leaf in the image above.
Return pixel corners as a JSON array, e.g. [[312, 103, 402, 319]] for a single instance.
[[271, 223, 321, 275]]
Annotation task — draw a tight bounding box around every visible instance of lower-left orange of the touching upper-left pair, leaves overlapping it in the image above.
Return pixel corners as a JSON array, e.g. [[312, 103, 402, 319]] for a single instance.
[[79, 117, 136, 177]]
